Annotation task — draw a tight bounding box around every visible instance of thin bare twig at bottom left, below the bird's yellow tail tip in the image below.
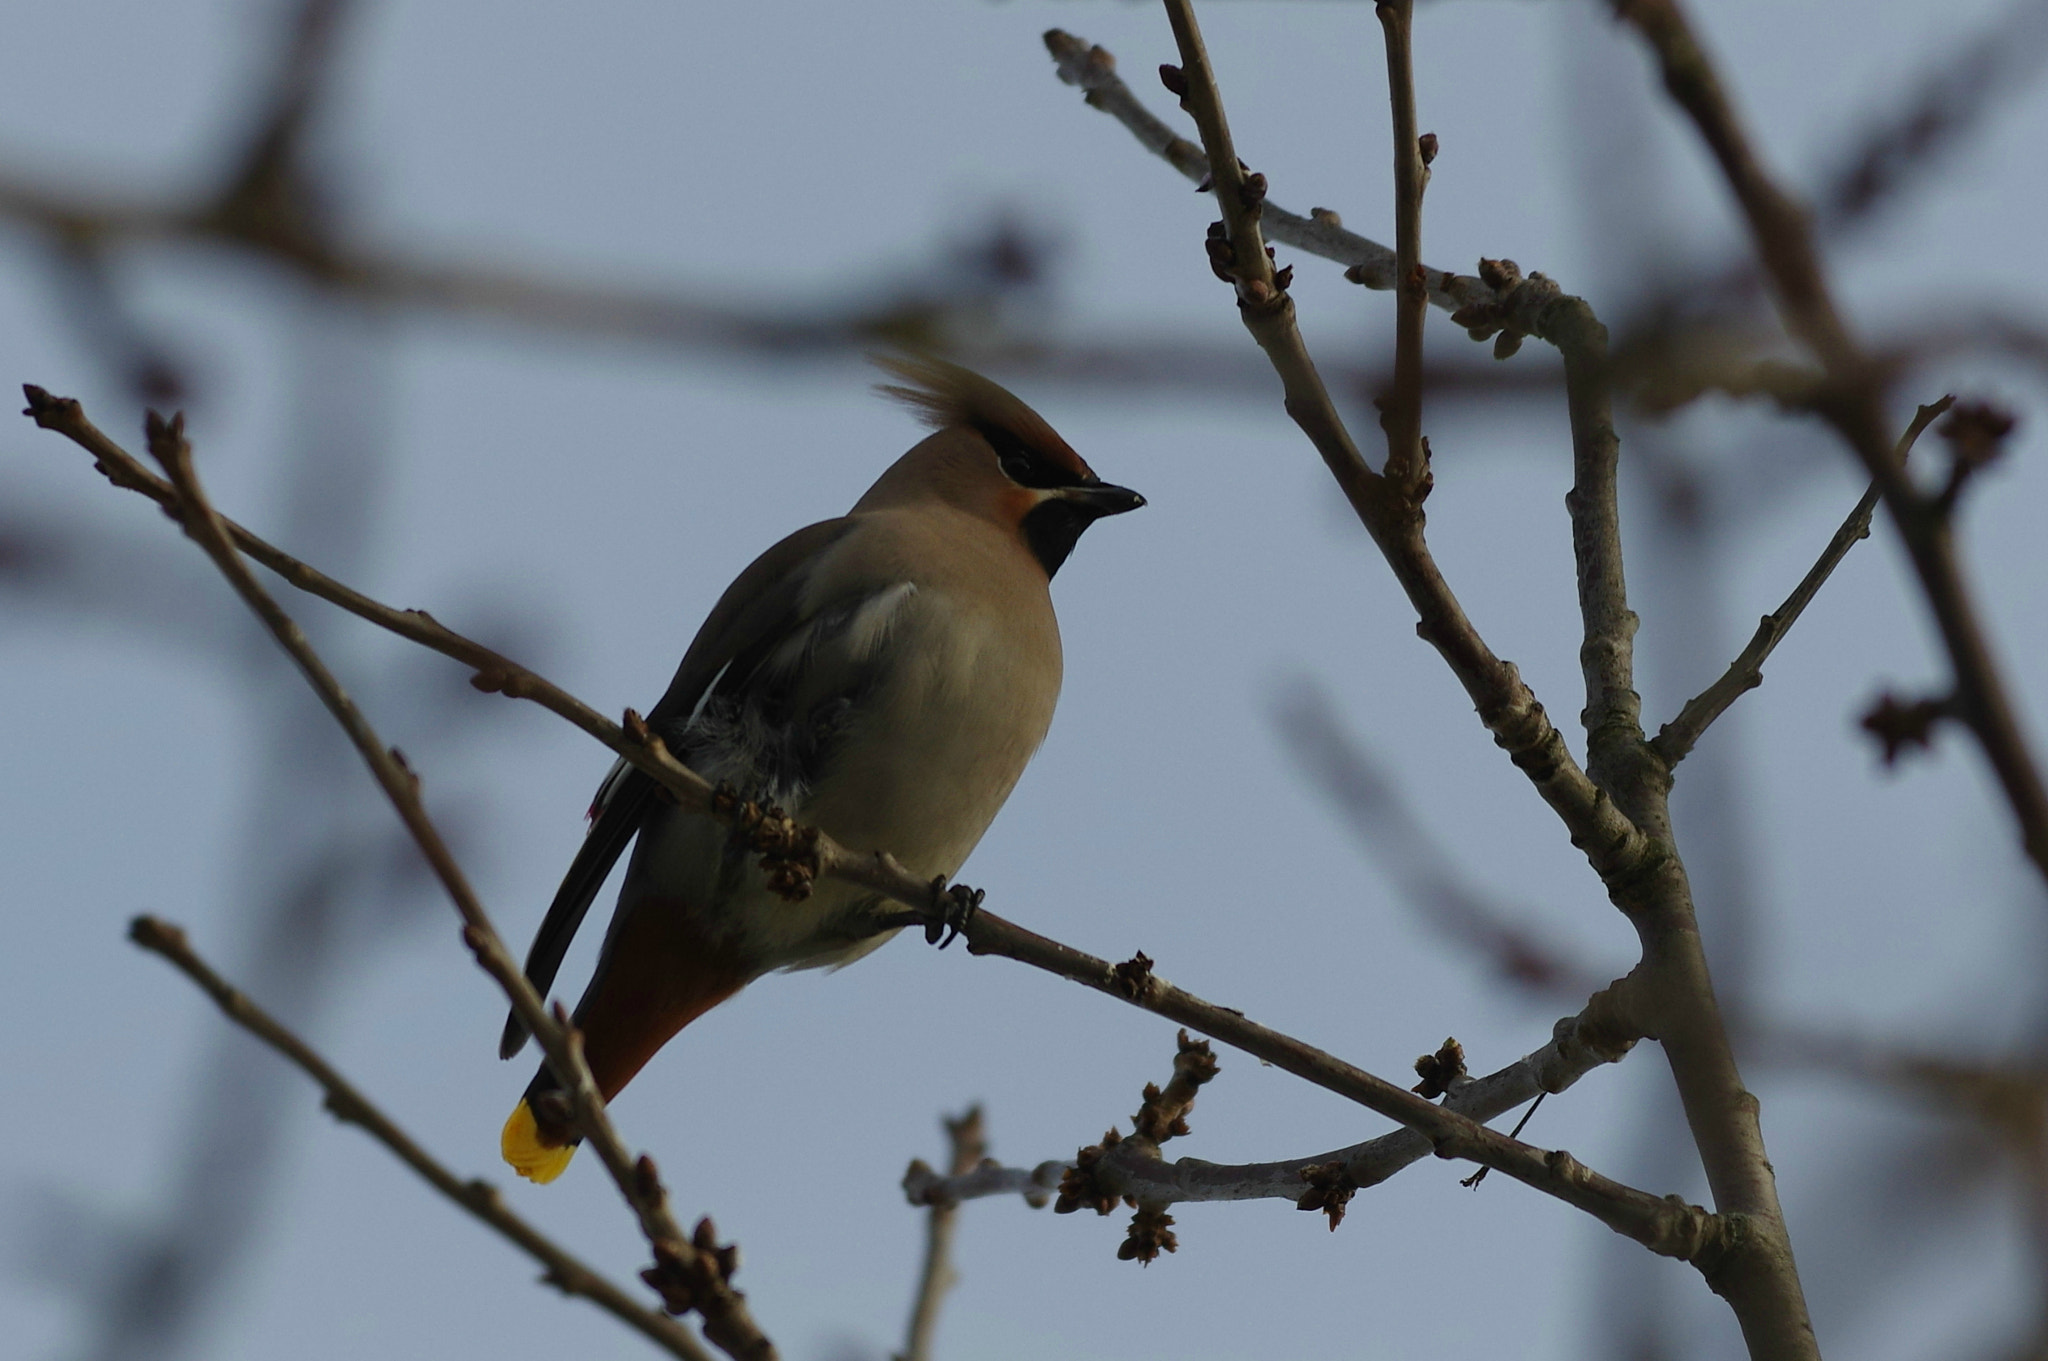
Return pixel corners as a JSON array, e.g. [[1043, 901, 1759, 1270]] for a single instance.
[[129, 917, 711, 1361]]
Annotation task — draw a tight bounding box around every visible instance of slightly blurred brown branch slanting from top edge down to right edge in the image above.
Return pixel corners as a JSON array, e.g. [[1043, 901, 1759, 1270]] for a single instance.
[[1616, 0, 2048, 878]]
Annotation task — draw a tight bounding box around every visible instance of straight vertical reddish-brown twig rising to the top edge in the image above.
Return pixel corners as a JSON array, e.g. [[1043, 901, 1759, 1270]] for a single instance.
[[1376, 0, 1434, 499]]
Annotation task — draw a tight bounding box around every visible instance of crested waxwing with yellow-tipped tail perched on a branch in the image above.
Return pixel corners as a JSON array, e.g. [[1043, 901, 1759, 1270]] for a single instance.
[[500, 354, 1145, 1183]]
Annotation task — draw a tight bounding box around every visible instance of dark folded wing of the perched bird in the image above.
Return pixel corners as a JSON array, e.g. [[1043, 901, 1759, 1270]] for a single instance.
[[498, 520, 868, 1058]]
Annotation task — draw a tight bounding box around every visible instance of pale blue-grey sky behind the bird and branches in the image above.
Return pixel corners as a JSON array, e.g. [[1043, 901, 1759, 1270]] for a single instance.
[[0, 0, 2048, 1361]]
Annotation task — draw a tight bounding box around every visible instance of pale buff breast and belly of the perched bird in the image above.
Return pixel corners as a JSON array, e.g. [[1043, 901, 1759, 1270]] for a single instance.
[[635, 514, 1061, 974]]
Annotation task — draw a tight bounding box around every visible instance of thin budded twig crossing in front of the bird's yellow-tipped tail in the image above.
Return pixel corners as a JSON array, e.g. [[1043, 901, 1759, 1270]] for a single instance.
[[92, 393, 774, 1361]]
